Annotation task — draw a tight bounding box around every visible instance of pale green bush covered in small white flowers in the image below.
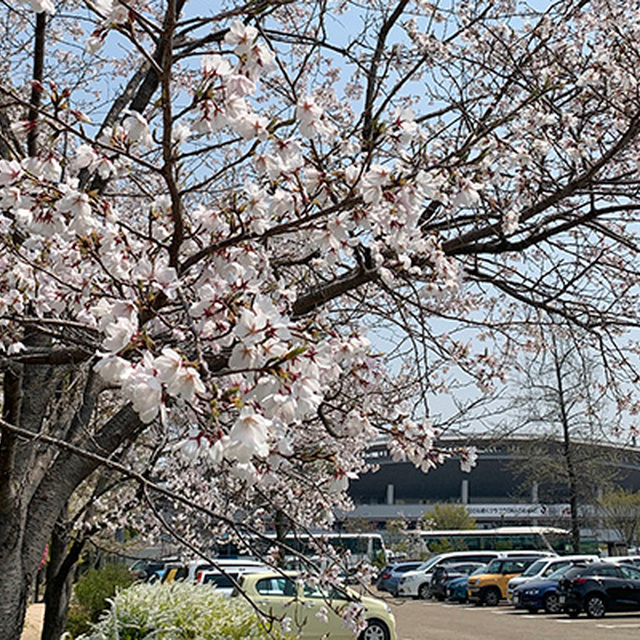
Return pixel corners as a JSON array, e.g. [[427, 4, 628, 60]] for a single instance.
[[78, 582, 282, 640]]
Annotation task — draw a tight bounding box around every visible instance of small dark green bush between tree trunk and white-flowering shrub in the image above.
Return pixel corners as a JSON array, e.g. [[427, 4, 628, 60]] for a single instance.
[[67, 563, 134, 636]]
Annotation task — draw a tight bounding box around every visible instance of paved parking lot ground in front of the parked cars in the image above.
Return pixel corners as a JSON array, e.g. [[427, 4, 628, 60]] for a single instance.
[[378, 592, 640, 640]]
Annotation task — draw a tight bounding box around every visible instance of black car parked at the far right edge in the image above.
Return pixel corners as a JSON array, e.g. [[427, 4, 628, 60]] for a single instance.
[[558, 562, 640, 618]]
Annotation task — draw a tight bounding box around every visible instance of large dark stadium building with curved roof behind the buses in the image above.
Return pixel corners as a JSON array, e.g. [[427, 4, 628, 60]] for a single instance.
[[345, 436, 640, 538]]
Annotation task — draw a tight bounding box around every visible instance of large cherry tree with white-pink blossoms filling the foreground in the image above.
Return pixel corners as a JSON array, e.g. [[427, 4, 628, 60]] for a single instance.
[[0, 0, 640, 640]]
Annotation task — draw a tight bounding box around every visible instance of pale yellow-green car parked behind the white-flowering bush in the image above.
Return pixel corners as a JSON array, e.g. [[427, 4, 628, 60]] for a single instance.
[[232, 571, 397, 640]]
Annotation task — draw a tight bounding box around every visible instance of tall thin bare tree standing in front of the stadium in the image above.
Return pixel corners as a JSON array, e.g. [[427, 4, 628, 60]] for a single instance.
[[504, 324, 620, 551]]
